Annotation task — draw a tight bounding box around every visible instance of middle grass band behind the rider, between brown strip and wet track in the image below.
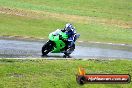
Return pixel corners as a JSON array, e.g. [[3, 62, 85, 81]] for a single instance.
[[0, 14, 132, 44]]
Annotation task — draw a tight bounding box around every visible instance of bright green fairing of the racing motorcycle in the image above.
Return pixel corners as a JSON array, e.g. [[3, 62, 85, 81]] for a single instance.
[[49, 31, 68, 53]]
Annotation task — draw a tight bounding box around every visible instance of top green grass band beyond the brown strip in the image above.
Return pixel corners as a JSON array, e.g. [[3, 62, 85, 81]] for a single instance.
[[0, 0, 132, 21]]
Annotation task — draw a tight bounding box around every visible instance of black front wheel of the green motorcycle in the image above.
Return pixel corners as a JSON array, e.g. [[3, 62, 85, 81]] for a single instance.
[[42, 40, 54, 56]]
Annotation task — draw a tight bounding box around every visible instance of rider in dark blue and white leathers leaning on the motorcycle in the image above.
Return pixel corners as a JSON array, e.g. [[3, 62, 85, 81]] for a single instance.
[[53, 23, 80, 52]]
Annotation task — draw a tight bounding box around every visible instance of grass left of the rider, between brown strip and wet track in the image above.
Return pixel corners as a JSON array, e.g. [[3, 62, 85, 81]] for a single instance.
[[0, 14, 64, 38]]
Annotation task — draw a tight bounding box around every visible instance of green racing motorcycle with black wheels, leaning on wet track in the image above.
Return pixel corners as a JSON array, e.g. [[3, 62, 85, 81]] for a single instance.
[[42, 30, 80, 58]]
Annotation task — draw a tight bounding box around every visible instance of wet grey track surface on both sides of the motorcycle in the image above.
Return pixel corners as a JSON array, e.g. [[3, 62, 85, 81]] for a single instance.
[[0, 39, 132, 59]]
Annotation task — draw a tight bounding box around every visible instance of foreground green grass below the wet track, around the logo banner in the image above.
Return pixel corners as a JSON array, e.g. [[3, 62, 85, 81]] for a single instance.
[[0, 59, 132, 88]]
